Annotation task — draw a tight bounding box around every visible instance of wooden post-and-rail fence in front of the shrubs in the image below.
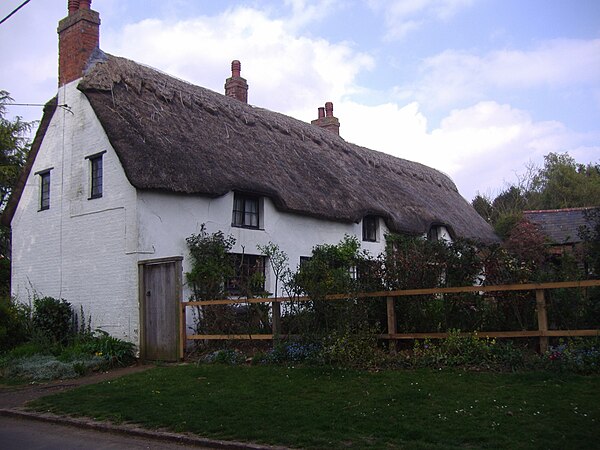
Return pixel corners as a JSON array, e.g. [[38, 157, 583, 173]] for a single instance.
[[179, 280, 600, 358]]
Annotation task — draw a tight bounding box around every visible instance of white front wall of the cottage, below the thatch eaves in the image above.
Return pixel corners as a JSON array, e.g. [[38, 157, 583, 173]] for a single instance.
[[137, 192, 387, 330]]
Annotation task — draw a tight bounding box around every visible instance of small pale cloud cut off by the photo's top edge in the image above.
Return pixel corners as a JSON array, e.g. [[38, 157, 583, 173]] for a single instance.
[[368, 0, 475, 40]]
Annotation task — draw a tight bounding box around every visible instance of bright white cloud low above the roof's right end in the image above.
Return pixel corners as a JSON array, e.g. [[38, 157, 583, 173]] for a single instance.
[[334, 101, 600, 200]]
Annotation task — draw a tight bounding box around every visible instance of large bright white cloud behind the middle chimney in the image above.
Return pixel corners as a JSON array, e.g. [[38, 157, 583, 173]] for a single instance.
[[104, 8, 374, 114]]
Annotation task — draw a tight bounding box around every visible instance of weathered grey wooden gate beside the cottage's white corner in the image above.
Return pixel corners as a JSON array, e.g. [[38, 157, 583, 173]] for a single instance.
[[139, 257, 183, 361]]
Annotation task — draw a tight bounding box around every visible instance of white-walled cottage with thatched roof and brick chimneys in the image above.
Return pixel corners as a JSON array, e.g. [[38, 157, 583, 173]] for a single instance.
[[3, 0, 495, 359]]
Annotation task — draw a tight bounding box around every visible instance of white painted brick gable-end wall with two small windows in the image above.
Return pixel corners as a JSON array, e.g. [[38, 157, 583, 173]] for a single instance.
[[12, 81, 139, 343]]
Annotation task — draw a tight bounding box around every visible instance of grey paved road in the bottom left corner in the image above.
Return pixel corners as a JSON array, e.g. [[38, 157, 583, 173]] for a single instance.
[[0, 416, 212, 450]]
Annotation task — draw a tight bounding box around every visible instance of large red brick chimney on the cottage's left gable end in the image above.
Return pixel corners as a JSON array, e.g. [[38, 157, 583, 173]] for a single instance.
[[57, 0, 100, 87]]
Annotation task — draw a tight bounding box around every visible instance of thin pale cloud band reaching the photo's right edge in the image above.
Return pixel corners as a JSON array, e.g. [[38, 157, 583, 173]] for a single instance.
[[397, 39, 600, 108]]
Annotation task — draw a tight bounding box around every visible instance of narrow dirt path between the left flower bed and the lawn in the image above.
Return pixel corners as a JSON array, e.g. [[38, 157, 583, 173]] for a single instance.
[[0, 364, 154, 409]]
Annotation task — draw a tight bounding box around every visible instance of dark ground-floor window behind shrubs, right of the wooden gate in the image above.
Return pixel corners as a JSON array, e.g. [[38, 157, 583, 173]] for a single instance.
[[225, 253, 265, 297]]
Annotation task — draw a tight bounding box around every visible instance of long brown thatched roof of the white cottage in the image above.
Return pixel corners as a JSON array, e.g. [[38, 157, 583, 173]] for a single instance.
[[4, 51, 497, 242]]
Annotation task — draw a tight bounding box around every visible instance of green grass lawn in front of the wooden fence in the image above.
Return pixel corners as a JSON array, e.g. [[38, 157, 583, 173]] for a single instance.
[[31, 365, 600, 449]]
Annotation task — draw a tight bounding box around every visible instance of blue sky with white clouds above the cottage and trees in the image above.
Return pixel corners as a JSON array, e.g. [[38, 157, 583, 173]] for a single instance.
[[0, 0, 600, 201]]
